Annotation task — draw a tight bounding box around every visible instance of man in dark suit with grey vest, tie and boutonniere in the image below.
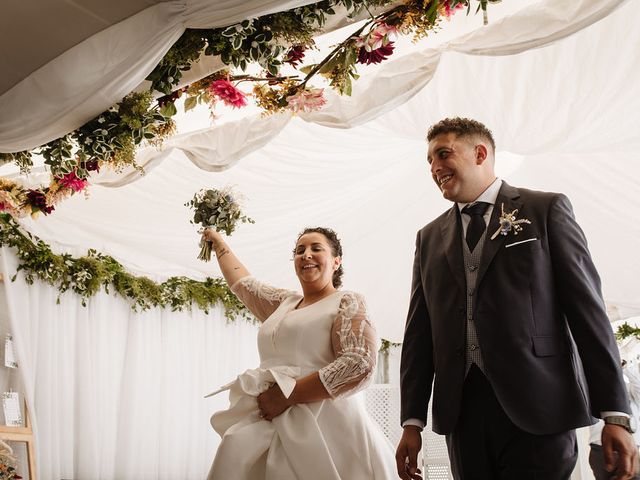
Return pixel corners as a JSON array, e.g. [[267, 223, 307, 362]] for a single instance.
[[396, 118, 638, 480]]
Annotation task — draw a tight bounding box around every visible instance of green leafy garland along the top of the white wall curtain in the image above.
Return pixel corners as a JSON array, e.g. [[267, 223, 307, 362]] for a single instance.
[[0, 213, 400, 353]]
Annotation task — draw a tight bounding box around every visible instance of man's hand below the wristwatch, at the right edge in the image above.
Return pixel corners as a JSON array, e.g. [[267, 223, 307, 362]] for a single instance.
[[602, 425, 640, 480]]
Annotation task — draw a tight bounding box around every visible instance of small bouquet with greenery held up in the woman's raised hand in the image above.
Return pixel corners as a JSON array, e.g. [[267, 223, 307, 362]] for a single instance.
[[185, 187, 255, 262]]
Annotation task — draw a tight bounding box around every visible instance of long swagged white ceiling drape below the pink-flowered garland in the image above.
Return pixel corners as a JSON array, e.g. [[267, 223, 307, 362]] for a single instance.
[[50, 0, 625, 186]]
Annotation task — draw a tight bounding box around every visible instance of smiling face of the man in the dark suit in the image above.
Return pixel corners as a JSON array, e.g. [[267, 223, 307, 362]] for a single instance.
[[427, 132, 478, 203]]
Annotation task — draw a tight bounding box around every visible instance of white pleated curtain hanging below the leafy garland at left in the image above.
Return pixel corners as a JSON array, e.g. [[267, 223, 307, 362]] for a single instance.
[[0, 249, 258, 480]]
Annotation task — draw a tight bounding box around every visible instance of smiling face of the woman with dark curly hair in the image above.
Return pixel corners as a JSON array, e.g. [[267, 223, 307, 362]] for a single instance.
[[293, 232, 340, 289]]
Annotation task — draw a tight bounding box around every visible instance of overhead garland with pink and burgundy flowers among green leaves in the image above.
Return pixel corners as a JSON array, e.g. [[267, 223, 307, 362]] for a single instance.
[[0, 0, 500, 218]]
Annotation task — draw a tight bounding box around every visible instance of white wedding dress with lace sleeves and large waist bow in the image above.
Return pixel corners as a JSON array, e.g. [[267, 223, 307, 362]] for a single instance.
[[208, 277, 397, 480]]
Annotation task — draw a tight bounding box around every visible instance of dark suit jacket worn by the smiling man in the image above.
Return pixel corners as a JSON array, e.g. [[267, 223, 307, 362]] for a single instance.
[[401, 183, 630, 434]]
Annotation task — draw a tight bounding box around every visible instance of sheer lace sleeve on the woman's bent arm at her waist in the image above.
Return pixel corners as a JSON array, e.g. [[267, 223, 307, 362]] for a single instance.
[[318, 292, 378, 398]]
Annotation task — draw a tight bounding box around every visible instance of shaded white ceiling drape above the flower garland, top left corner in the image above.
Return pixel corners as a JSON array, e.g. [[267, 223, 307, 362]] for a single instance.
[[0, 0, 320, 152]]
